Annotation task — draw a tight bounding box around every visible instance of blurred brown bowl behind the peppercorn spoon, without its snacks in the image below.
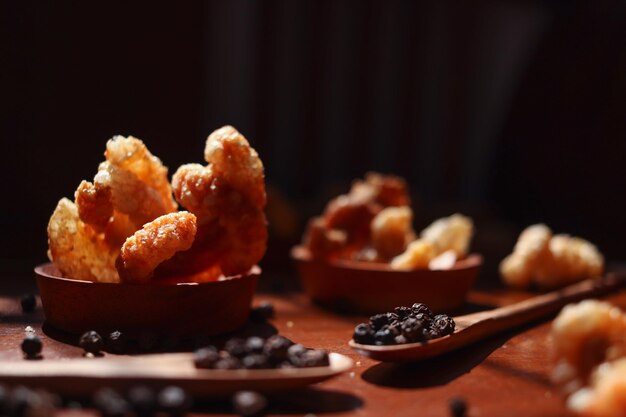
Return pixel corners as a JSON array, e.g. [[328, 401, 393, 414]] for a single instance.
[[291, 246, 483, 314]]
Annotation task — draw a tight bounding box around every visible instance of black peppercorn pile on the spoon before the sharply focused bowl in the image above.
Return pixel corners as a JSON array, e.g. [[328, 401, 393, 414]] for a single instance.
[[194, 335, 330, 369]]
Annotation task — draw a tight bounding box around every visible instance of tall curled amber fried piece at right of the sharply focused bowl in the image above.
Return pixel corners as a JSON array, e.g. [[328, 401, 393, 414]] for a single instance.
[[166, 126, 267, 275]]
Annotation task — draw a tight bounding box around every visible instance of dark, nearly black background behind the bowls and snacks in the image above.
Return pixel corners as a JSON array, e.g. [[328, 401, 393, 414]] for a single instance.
[[0, 0, 626, 290]]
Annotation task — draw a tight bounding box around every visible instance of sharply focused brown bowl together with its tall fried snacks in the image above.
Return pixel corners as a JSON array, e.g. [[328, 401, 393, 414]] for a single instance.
[[41, 126, 267, 335]]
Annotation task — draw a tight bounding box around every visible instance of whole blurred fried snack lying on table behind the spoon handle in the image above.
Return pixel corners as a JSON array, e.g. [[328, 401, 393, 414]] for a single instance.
[[500, 224, 604, 290]]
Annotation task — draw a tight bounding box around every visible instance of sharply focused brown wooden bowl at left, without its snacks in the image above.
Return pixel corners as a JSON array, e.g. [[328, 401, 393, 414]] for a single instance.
[[35, 263, 261, 336]]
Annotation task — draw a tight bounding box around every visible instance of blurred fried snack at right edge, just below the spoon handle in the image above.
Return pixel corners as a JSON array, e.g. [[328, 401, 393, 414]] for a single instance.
[[552, 300, 626, 394]]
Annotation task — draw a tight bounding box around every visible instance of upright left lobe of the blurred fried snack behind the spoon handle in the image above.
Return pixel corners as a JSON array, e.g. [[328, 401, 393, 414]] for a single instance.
[[500, 224, 552, 289]]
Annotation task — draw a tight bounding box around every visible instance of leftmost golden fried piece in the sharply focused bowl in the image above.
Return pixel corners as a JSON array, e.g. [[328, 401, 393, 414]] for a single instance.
[[48, 198, 119, 282]]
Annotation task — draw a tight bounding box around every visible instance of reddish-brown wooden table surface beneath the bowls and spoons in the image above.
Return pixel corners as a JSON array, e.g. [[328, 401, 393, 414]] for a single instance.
[[0, 286, 626, 417]]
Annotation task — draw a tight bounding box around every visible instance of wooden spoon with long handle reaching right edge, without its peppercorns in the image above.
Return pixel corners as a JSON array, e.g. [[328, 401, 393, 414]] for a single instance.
[[348, 274, 626, 362]]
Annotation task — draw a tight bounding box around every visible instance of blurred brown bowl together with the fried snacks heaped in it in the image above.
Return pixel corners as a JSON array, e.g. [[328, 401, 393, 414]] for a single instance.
[[291, 173, 482, 314]]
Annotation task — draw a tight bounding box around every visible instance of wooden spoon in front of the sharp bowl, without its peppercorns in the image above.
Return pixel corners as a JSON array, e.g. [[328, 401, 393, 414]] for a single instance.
[[0, 352, 353, 397]]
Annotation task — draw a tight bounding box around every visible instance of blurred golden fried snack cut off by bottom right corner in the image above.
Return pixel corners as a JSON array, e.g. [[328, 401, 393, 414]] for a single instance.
[[567, 358, 626, 417]]
